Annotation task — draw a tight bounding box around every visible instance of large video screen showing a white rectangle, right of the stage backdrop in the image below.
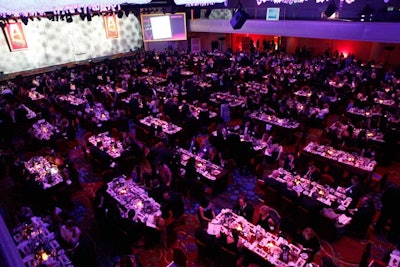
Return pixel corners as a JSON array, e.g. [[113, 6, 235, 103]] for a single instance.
[[141, 13, 187, 42]]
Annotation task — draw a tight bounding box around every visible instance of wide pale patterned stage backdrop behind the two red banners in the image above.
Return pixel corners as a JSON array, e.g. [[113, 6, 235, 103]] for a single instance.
[[0, 14, 143, 74]]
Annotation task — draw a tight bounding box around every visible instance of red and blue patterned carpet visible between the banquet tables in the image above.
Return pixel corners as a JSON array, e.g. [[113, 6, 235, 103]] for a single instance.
[[0, 122, 400, 267]]
